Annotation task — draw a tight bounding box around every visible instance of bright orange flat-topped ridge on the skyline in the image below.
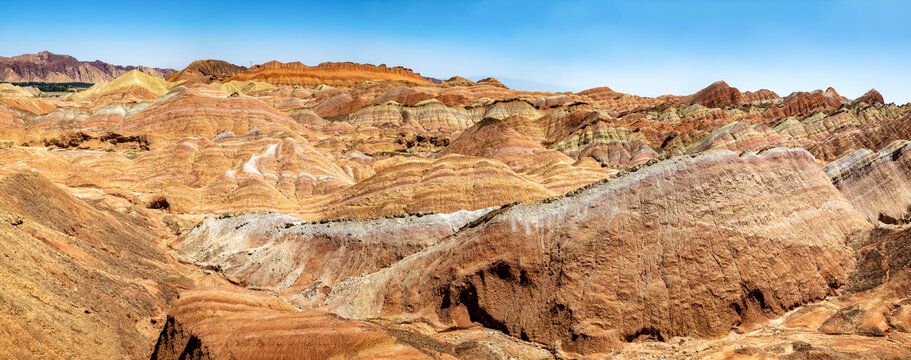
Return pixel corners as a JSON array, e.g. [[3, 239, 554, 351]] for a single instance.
[[230, 61, 431, 87]]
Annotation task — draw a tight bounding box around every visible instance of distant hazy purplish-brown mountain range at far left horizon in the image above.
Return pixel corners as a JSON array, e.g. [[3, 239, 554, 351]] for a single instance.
[[0, 51, 176, 83]]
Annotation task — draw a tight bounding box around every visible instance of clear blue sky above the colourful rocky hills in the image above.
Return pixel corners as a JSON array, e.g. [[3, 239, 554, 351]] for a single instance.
[[0, 0, 911, 104]]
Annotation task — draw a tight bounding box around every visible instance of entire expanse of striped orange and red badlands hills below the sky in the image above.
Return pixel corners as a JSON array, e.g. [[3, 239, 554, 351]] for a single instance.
[[0, 60, 911, 359]]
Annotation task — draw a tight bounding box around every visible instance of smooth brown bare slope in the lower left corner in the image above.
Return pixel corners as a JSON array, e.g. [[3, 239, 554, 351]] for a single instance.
[[0, 173, 200, 359]]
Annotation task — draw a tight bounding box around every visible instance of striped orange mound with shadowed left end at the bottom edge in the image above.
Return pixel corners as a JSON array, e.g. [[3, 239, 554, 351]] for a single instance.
[[151, 288, 431, 360]]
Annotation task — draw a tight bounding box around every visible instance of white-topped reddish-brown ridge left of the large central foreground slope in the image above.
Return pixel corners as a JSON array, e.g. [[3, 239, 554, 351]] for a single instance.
[[174, 209, 489, 301]]
